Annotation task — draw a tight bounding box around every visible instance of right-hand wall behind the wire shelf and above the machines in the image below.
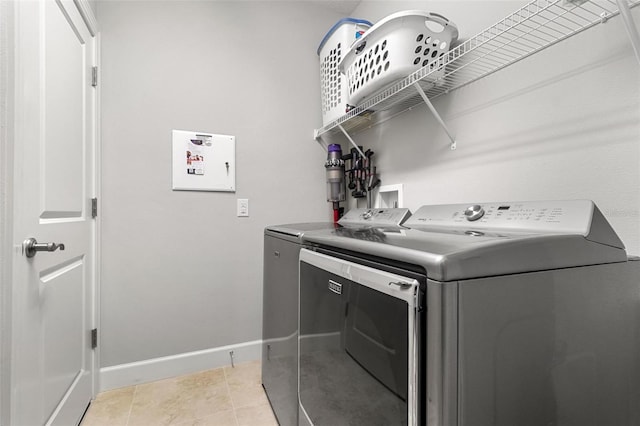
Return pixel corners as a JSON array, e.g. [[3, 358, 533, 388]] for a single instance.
[[353, 0, 640, 255]]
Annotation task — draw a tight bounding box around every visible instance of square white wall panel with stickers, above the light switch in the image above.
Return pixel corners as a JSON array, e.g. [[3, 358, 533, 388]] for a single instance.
[[172, 130, 236, 192]]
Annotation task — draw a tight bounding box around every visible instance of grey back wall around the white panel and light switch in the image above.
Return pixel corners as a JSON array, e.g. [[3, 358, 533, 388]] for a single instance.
[[98, 1, 339, 367]]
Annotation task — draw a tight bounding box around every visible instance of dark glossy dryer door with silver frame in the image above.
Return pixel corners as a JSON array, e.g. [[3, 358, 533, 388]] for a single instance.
[[299, 249, 419, 425]]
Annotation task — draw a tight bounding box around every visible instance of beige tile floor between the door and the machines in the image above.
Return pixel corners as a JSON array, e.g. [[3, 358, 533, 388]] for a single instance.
[[81, 361, 278, 426]]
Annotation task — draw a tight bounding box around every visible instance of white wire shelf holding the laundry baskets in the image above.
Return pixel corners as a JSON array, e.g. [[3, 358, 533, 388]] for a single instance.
[[315, 0, 640, 139]]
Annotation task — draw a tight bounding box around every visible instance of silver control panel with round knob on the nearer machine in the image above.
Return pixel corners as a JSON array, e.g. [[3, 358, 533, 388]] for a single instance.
[[404, 200, 594, 235]]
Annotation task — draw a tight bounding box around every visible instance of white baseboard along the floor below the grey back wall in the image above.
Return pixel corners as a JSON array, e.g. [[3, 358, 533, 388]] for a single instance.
[[100, 340, 262, 392]]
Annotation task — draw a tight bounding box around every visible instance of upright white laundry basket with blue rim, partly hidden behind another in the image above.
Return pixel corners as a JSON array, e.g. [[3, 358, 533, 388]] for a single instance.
[[318, 18, 373, 125]]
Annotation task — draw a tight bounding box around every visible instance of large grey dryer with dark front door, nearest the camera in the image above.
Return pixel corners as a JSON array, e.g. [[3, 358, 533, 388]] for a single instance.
[[298, 200, 640, 426]]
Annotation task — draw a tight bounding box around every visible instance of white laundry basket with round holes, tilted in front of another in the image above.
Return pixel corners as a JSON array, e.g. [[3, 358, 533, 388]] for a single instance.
[[339, 10, 458, 106]]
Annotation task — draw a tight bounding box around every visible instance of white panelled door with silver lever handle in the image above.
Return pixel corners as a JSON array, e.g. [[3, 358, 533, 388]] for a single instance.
[[10, 0, 96, 426]]
